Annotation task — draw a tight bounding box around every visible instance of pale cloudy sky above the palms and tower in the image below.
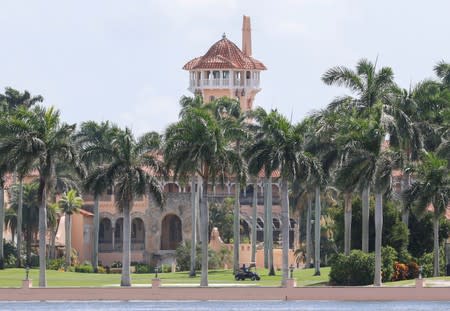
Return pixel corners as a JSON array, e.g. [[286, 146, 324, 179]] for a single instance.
[[0, 0, 450, 135]]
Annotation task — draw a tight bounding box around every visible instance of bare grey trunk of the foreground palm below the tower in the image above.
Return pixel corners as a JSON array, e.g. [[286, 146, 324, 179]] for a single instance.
[[200, 177, 209, 286]]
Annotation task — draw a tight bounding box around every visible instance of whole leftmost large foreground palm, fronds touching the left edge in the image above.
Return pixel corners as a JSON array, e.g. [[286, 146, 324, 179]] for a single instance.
[[0, 106, 77, 287]]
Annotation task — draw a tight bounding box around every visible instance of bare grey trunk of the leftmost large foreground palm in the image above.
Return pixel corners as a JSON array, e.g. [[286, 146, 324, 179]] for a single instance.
[[39, 180, 47, 287]]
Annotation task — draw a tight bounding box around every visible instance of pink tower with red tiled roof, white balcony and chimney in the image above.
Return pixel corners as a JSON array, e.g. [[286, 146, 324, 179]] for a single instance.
[[183, 15, 266, 111]]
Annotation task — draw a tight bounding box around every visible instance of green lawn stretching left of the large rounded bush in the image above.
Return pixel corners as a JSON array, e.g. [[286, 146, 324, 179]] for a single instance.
[[0, 268, 330, 287]]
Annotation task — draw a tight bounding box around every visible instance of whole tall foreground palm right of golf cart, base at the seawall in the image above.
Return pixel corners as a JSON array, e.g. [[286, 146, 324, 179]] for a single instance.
[[246, 108, 311, 286]]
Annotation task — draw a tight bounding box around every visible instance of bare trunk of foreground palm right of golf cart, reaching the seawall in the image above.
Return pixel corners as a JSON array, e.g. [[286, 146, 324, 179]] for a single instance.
[[281, 178, 289, 286]]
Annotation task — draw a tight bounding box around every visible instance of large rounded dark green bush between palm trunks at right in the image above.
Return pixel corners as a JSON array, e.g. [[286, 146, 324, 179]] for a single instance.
[[330, 250, 375, 285]]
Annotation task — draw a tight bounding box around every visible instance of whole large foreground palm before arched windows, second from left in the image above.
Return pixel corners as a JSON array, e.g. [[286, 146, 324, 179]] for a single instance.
[[86, 128, 164, 286]]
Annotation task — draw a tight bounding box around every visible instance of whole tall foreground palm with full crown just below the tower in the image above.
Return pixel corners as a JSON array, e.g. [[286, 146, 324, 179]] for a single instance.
[[164, 97, 236, 286]]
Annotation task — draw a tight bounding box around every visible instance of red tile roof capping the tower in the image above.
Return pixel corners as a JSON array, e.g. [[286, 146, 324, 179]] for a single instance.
[[183, 36, 267, 70]]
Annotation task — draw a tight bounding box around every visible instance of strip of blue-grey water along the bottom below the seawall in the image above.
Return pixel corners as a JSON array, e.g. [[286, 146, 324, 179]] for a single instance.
[[0, 301, 450, 311]]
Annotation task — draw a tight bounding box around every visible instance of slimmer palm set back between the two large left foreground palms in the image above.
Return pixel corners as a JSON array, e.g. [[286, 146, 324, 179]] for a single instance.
[[75, 121, 119, 271]]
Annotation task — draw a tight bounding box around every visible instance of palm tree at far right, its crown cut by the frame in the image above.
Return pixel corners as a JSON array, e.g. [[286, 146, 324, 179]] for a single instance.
[[406, 152, 450, 277]]
